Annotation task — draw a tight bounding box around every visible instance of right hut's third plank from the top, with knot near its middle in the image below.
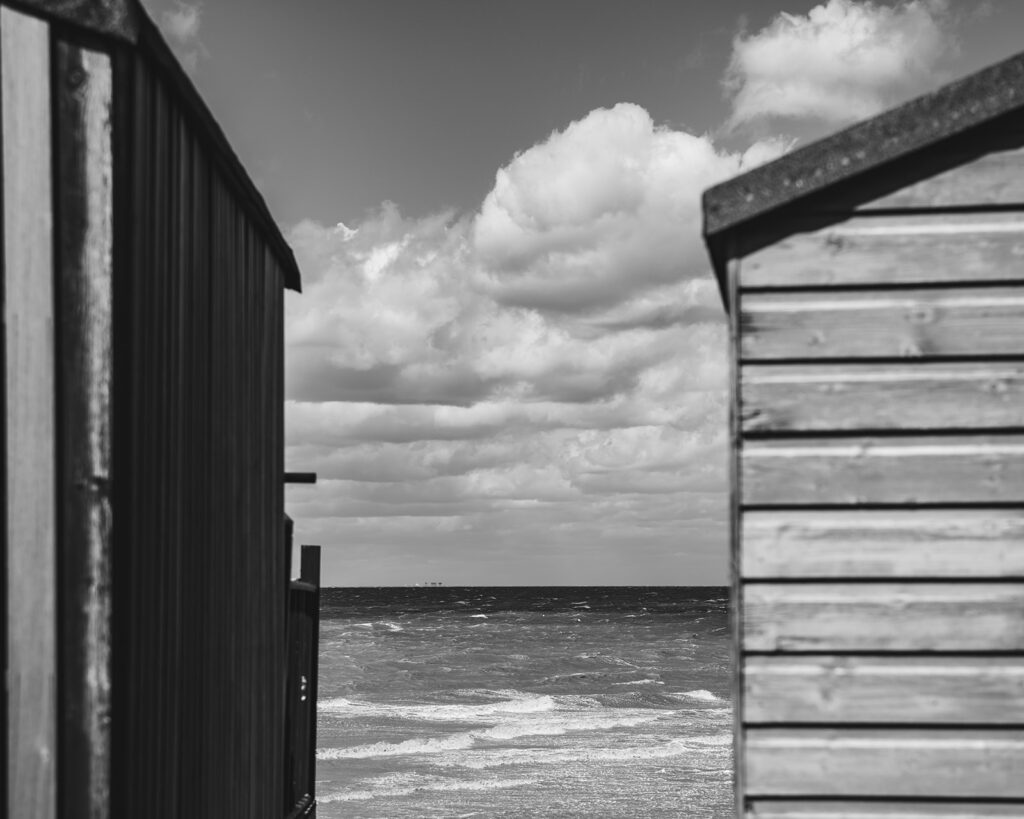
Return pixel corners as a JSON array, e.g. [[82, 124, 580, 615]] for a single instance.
[[740, 288, 1024, 360]]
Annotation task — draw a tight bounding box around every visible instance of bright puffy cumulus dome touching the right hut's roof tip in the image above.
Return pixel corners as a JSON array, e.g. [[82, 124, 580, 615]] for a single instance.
[[473, 103, 760, 314]]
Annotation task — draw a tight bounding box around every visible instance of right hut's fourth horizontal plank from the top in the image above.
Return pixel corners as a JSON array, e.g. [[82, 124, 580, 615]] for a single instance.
[[742, 361, 1024, 433]]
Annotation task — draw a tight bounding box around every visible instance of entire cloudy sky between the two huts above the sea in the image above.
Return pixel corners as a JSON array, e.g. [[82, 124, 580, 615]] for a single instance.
[[145, 0, 1024, 586]]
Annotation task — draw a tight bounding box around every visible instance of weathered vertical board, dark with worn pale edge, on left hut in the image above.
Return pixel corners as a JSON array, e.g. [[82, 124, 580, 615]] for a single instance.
[[53, 41, 114, 817]]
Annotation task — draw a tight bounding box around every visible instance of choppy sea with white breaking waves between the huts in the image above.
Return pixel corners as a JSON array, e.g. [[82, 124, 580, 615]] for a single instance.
[[316, 587, 732, 819]]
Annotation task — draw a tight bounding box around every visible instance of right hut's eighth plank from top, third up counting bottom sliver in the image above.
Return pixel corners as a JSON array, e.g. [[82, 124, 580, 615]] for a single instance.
[[742, 655, 1024, 726]]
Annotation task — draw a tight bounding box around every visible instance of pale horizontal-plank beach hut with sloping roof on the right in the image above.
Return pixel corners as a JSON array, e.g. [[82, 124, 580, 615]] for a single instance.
[[703, 54, 1024, 819]]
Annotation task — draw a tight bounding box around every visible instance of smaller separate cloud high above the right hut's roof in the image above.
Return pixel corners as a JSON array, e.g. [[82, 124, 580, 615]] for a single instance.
[[725, 0, 955, 127]]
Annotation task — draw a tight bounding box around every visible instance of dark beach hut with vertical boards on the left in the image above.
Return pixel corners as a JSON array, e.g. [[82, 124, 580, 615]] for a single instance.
[[0, 0, 316, 819]]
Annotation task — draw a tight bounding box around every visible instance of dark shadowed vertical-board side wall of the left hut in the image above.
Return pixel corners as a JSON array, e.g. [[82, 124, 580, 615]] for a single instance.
[[113, 43, 288, 819]]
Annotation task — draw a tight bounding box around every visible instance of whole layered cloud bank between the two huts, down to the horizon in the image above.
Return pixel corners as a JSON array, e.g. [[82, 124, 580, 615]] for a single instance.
[[286, 104, 781, 584]]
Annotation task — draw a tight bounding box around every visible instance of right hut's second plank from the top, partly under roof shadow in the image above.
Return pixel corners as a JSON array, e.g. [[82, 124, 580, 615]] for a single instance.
[[741, 212, 1024, 288]]
